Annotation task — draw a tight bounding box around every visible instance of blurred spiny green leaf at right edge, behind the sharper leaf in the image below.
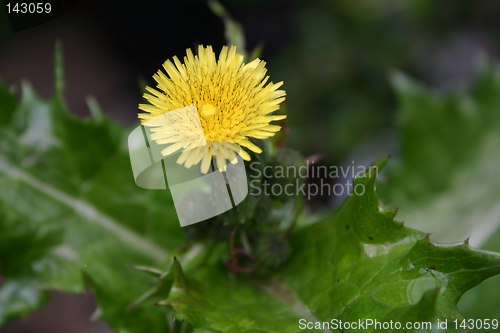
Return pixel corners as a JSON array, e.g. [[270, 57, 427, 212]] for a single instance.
[[379, 64, 500, 318]]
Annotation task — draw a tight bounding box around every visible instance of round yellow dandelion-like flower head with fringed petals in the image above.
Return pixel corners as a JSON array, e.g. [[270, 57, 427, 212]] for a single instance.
[[139, 46, 286, 173]]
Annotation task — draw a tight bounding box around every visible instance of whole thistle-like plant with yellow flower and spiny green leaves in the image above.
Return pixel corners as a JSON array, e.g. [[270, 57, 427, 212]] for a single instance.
[[0, 2, 500, 333]]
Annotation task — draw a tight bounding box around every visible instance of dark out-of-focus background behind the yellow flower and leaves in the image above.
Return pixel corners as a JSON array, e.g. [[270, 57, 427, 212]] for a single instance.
[[0, 0, 500, 333]]
